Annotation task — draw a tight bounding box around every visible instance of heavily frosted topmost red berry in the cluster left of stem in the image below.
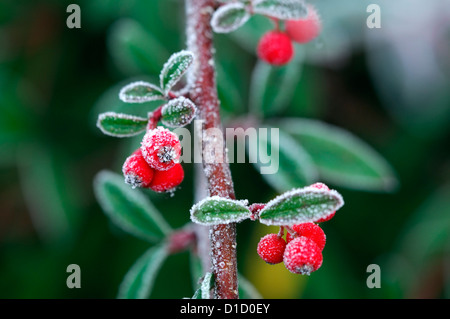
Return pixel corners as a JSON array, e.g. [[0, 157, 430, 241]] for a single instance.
[[141, 127, 181, 171]]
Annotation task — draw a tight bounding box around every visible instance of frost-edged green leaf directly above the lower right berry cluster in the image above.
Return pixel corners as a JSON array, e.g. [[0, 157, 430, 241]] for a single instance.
[[259, 187, 344, 226]]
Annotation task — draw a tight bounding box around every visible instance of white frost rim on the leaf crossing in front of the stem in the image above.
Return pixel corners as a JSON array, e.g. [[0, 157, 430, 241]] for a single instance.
[[190, 196, 251, 226]]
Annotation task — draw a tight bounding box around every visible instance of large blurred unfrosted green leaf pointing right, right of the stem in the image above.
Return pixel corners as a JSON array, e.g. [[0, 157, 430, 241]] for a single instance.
[[277, 119, 398, 191]]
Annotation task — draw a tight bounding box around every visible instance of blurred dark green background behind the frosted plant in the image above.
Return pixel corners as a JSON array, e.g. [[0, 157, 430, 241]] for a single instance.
[[0, 0, 450, 298]]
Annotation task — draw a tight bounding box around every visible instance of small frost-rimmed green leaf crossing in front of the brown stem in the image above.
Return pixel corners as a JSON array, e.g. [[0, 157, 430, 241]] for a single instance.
[[191, 196, 251, 226]]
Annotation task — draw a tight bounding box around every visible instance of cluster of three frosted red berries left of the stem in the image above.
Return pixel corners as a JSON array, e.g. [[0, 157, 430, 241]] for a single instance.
[[122, 127, 184, 192]]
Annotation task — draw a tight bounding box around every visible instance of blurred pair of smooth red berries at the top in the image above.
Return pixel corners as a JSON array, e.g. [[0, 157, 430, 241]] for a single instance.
[[257, 5, 322, 66]]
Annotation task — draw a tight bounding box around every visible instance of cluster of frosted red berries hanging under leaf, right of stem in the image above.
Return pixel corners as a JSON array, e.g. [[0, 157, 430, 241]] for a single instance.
[[257, 183, 334, 275]]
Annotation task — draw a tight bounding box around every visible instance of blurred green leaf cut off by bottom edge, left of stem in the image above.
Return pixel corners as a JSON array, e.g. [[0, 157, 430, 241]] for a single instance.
[[117, 244, 168, 299]]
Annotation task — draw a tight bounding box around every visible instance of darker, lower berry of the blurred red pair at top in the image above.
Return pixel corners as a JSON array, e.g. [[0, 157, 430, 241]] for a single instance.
[[257, 31, 294, 65]]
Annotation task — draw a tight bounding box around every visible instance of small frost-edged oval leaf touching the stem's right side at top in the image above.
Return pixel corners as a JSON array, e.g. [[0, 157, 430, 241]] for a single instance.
[[211, 2, 250, 33]]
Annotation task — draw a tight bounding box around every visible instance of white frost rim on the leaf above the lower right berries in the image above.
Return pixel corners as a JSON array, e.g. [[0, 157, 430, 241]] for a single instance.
[[259, 186, 344, 226]]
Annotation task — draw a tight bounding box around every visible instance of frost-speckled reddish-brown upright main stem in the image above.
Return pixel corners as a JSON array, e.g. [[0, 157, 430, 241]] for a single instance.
[[186, 0, 238, 299]]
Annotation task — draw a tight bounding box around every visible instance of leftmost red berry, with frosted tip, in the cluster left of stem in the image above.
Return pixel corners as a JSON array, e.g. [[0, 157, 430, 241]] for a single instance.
[[122, 149, 154, 188]]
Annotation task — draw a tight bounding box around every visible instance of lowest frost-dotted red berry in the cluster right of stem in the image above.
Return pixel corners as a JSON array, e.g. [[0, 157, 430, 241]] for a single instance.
[[283, 236, 323, 275]]
